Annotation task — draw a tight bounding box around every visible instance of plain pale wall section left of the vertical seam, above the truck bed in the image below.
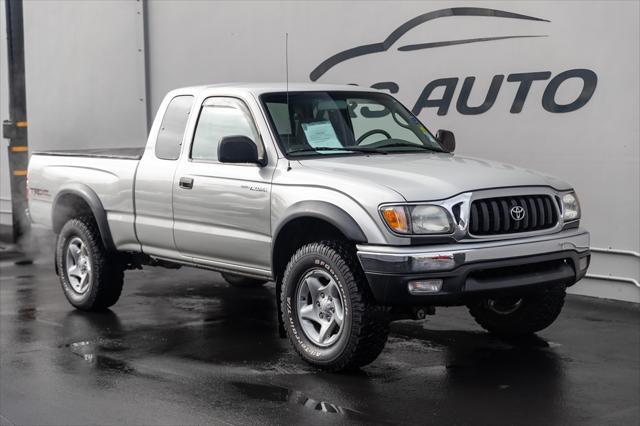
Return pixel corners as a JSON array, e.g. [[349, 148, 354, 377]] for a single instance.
[[0, 0, 147, 223]]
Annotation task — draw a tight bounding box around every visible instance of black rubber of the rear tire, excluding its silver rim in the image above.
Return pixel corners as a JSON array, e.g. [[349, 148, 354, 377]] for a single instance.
[[56, 216, 124, 311]]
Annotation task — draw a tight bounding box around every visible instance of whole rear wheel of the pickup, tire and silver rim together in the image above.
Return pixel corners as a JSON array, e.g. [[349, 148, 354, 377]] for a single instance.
[[56, 216, 124, 311]]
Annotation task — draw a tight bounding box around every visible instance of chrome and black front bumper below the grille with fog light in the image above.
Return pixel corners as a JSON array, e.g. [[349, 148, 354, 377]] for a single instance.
[[357, 228, 590, 305]]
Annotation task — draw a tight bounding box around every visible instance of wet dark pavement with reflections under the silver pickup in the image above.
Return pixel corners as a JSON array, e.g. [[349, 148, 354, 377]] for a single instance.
[[0, 255, 640, 425]]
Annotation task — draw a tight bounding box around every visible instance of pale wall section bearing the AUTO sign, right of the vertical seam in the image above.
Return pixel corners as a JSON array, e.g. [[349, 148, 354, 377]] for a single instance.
[[148, 1, 640, 302]]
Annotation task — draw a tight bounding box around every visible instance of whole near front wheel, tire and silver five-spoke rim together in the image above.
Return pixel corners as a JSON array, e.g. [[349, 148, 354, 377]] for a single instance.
[[280, 241, 389, 371]]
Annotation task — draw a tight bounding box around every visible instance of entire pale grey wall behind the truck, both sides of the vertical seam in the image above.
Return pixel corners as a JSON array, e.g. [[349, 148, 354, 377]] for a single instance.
[[0, 0, 640, 301]]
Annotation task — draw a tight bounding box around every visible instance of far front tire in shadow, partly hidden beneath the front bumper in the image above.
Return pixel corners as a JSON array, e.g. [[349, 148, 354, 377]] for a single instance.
[[468, 285, 566, 337]]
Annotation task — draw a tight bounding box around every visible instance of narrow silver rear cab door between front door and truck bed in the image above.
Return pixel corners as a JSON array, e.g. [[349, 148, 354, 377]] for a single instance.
[[134, 96, 194, 257]]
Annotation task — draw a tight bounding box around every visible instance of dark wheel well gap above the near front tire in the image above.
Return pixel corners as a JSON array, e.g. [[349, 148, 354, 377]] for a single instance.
[[272, 217, 349, 280]]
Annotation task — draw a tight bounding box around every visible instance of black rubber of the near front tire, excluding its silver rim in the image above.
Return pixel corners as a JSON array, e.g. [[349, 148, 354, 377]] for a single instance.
[[280, 241, 389, 371]]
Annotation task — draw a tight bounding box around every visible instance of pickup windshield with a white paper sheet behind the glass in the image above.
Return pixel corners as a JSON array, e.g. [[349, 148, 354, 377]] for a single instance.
[[261, 91, 443, 157]]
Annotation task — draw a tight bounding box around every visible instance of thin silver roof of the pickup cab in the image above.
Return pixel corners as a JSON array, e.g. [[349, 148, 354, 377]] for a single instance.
[[172, 82, 376, 95]]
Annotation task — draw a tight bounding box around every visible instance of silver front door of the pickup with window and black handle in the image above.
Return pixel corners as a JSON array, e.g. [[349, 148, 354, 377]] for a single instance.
[[173, 97, 274, 275]]
